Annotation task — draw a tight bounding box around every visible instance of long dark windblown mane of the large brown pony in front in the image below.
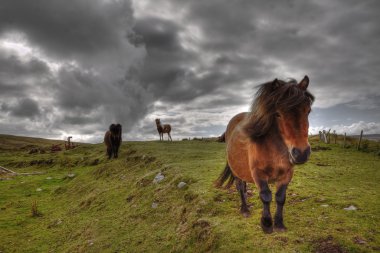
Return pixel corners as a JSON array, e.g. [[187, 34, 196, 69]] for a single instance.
[[245, 79, 314, 140]]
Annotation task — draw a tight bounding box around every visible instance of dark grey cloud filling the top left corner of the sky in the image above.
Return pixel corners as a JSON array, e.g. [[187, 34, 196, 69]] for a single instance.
[[0, 0, 133, 57]]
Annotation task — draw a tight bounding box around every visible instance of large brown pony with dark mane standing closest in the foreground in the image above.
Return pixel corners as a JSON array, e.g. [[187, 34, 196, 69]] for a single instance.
[[216, 76, 314, 233]]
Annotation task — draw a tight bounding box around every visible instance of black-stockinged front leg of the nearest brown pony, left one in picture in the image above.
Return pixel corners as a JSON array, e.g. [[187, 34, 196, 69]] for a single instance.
[[258, 180, 273, 233]]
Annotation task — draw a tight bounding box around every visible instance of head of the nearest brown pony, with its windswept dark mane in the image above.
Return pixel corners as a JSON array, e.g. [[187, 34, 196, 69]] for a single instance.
[[246, 76, 314, 164]]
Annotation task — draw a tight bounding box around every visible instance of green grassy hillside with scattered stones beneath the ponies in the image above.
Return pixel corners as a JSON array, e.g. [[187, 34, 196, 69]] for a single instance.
[[0, 135, 380, 253]]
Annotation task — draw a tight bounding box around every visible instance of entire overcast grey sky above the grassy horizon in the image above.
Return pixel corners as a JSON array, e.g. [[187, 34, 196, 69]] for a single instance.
[[0, 0, 380, 142]]
